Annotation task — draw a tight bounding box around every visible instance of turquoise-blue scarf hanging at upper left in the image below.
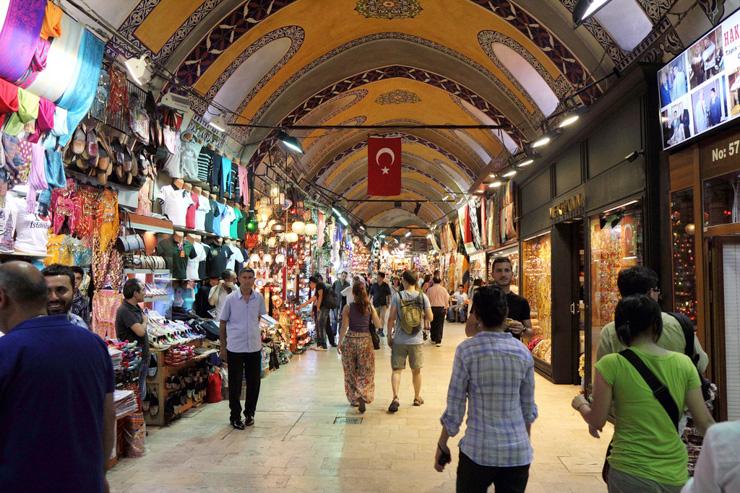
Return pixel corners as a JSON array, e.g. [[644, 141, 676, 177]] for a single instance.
[[57, 30, 105, 146]]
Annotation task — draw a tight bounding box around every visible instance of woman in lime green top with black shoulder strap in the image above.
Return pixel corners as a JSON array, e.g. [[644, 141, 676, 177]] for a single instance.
[[572, 295, 714, 493]]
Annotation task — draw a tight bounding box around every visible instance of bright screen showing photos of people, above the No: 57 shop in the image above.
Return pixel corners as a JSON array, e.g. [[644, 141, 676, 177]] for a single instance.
[[658, 10, 740, 149]]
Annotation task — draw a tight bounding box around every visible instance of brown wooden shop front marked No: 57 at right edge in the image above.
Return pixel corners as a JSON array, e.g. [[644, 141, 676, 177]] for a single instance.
[[669, 124, 740, 420]]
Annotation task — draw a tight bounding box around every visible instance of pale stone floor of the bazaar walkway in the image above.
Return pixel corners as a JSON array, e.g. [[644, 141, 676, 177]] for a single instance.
[[108, 324, 611, 493]]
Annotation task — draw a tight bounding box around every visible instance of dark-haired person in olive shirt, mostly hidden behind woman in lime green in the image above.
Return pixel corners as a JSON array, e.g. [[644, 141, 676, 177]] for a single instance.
[[596, 265, 709, 373]]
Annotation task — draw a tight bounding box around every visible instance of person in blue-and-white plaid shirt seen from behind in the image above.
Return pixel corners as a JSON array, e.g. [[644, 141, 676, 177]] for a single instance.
[[435, 286, 537, 492]]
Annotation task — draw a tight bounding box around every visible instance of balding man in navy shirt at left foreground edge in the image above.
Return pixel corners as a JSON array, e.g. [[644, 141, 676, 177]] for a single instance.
[[0, 262, 116, 493]]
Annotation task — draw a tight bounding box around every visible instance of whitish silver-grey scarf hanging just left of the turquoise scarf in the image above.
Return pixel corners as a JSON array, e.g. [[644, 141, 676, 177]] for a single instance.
[[28, 14, 84, 104]]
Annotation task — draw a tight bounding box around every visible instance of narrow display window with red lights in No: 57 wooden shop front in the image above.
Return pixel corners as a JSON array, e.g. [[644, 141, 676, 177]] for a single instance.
[[671, 189, 697, 323]]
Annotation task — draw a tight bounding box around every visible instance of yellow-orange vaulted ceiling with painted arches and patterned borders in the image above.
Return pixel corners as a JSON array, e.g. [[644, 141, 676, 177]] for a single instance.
[[73, 0, 700, 231]]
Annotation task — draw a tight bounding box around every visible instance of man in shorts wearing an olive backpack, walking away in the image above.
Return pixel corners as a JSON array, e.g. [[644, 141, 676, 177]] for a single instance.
[[388, 271, 433, 413]]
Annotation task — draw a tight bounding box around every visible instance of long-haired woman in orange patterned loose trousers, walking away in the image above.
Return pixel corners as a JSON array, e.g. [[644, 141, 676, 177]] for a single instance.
[[338, 281, 381, 413]]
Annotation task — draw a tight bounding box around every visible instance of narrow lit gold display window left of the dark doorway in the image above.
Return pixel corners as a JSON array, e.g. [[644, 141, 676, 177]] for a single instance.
[[521, 233, 552, 364]]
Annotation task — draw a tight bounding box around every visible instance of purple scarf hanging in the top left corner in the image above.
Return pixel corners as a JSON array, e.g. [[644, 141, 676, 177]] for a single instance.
[[0, 0, 46, 82]]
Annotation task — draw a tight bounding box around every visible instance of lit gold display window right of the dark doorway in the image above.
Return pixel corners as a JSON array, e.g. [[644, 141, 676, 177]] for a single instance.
[[589, 204, 643, 375]]
